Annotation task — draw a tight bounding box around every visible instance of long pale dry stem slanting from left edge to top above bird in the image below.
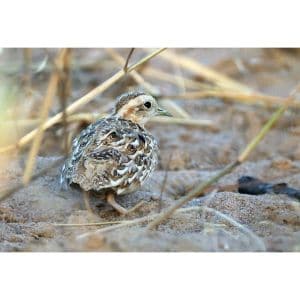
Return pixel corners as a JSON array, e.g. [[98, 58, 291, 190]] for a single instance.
[[0, 48, 165, 154]]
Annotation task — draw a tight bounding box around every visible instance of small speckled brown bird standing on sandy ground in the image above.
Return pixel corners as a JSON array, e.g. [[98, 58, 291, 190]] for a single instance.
[[61, 91, 171, 214]]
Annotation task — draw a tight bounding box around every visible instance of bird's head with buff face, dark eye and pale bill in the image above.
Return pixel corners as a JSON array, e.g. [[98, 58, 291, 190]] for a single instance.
[[114, 91, 172, 126]]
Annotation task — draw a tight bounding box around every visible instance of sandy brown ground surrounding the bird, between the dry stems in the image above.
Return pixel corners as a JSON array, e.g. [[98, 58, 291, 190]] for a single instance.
[[0, 49, 300, 251]]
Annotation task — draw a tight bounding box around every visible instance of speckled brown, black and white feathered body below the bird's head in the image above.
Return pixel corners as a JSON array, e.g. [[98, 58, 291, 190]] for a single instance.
[[61, 116, 158, 195]]
